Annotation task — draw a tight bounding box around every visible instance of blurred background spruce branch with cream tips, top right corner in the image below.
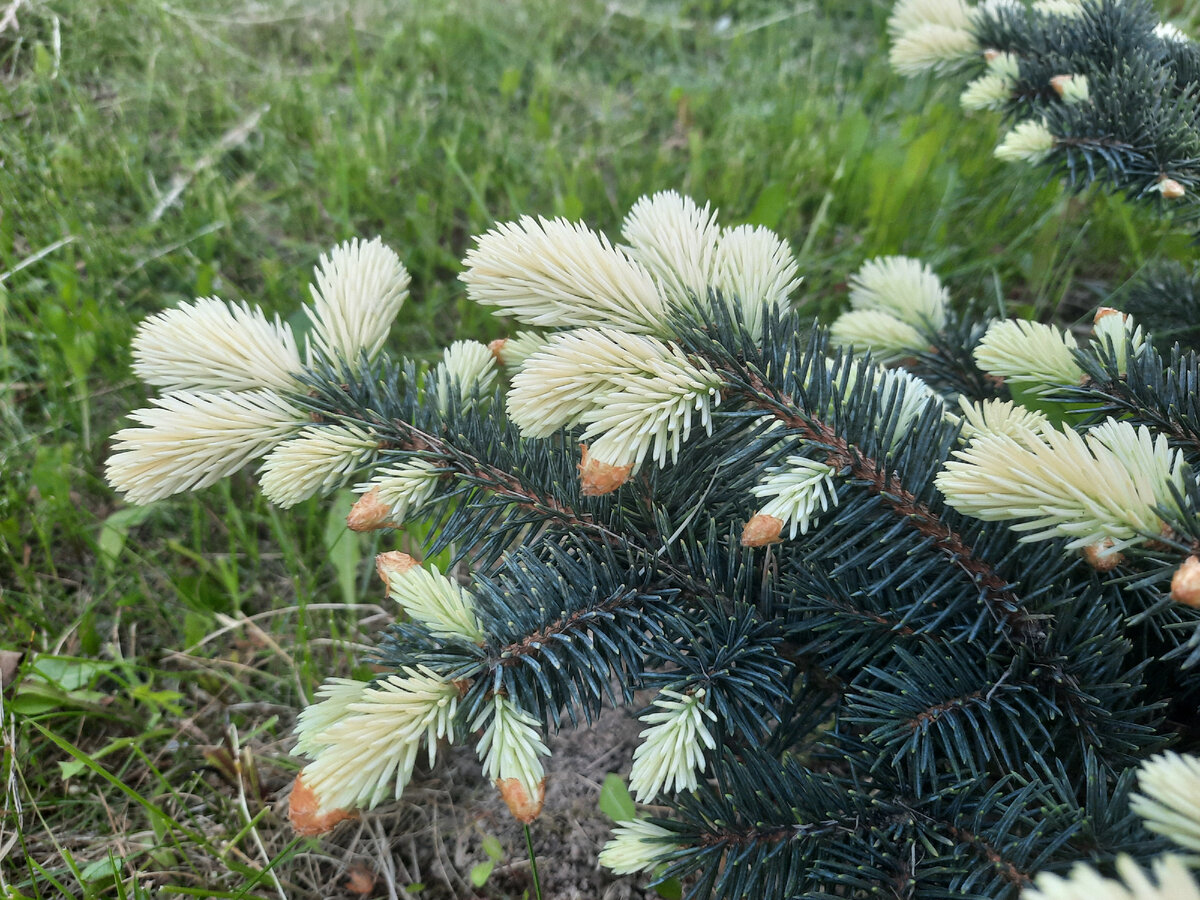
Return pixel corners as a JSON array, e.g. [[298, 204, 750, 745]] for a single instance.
[[890, 0, 1200, 221]]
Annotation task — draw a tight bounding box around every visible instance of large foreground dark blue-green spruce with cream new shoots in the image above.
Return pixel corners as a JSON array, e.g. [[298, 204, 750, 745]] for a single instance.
[[108, 7, 1200, 900]]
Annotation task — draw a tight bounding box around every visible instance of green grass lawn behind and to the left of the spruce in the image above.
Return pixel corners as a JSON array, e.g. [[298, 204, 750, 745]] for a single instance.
[[0, 0, 1200, 898]]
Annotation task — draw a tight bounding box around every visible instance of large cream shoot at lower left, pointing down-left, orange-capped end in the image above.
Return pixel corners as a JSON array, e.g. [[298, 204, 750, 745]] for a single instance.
[[293, 666, 460, 822]]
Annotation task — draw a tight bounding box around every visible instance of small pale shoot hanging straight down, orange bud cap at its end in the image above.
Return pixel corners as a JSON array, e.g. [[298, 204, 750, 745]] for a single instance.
[[470, 694, 550, 824]]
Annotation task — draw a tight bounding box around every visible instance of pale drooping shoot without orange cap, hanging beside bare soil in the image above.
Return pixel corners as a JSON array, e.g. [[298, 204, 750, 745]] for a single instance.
[[629, 688, 716, 803]]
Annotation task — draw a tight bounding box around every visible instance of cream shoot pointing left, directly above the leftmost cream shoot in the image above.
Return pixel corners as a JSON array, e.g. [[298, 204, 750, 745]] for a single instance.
[[133, 298, 304, 391]]
